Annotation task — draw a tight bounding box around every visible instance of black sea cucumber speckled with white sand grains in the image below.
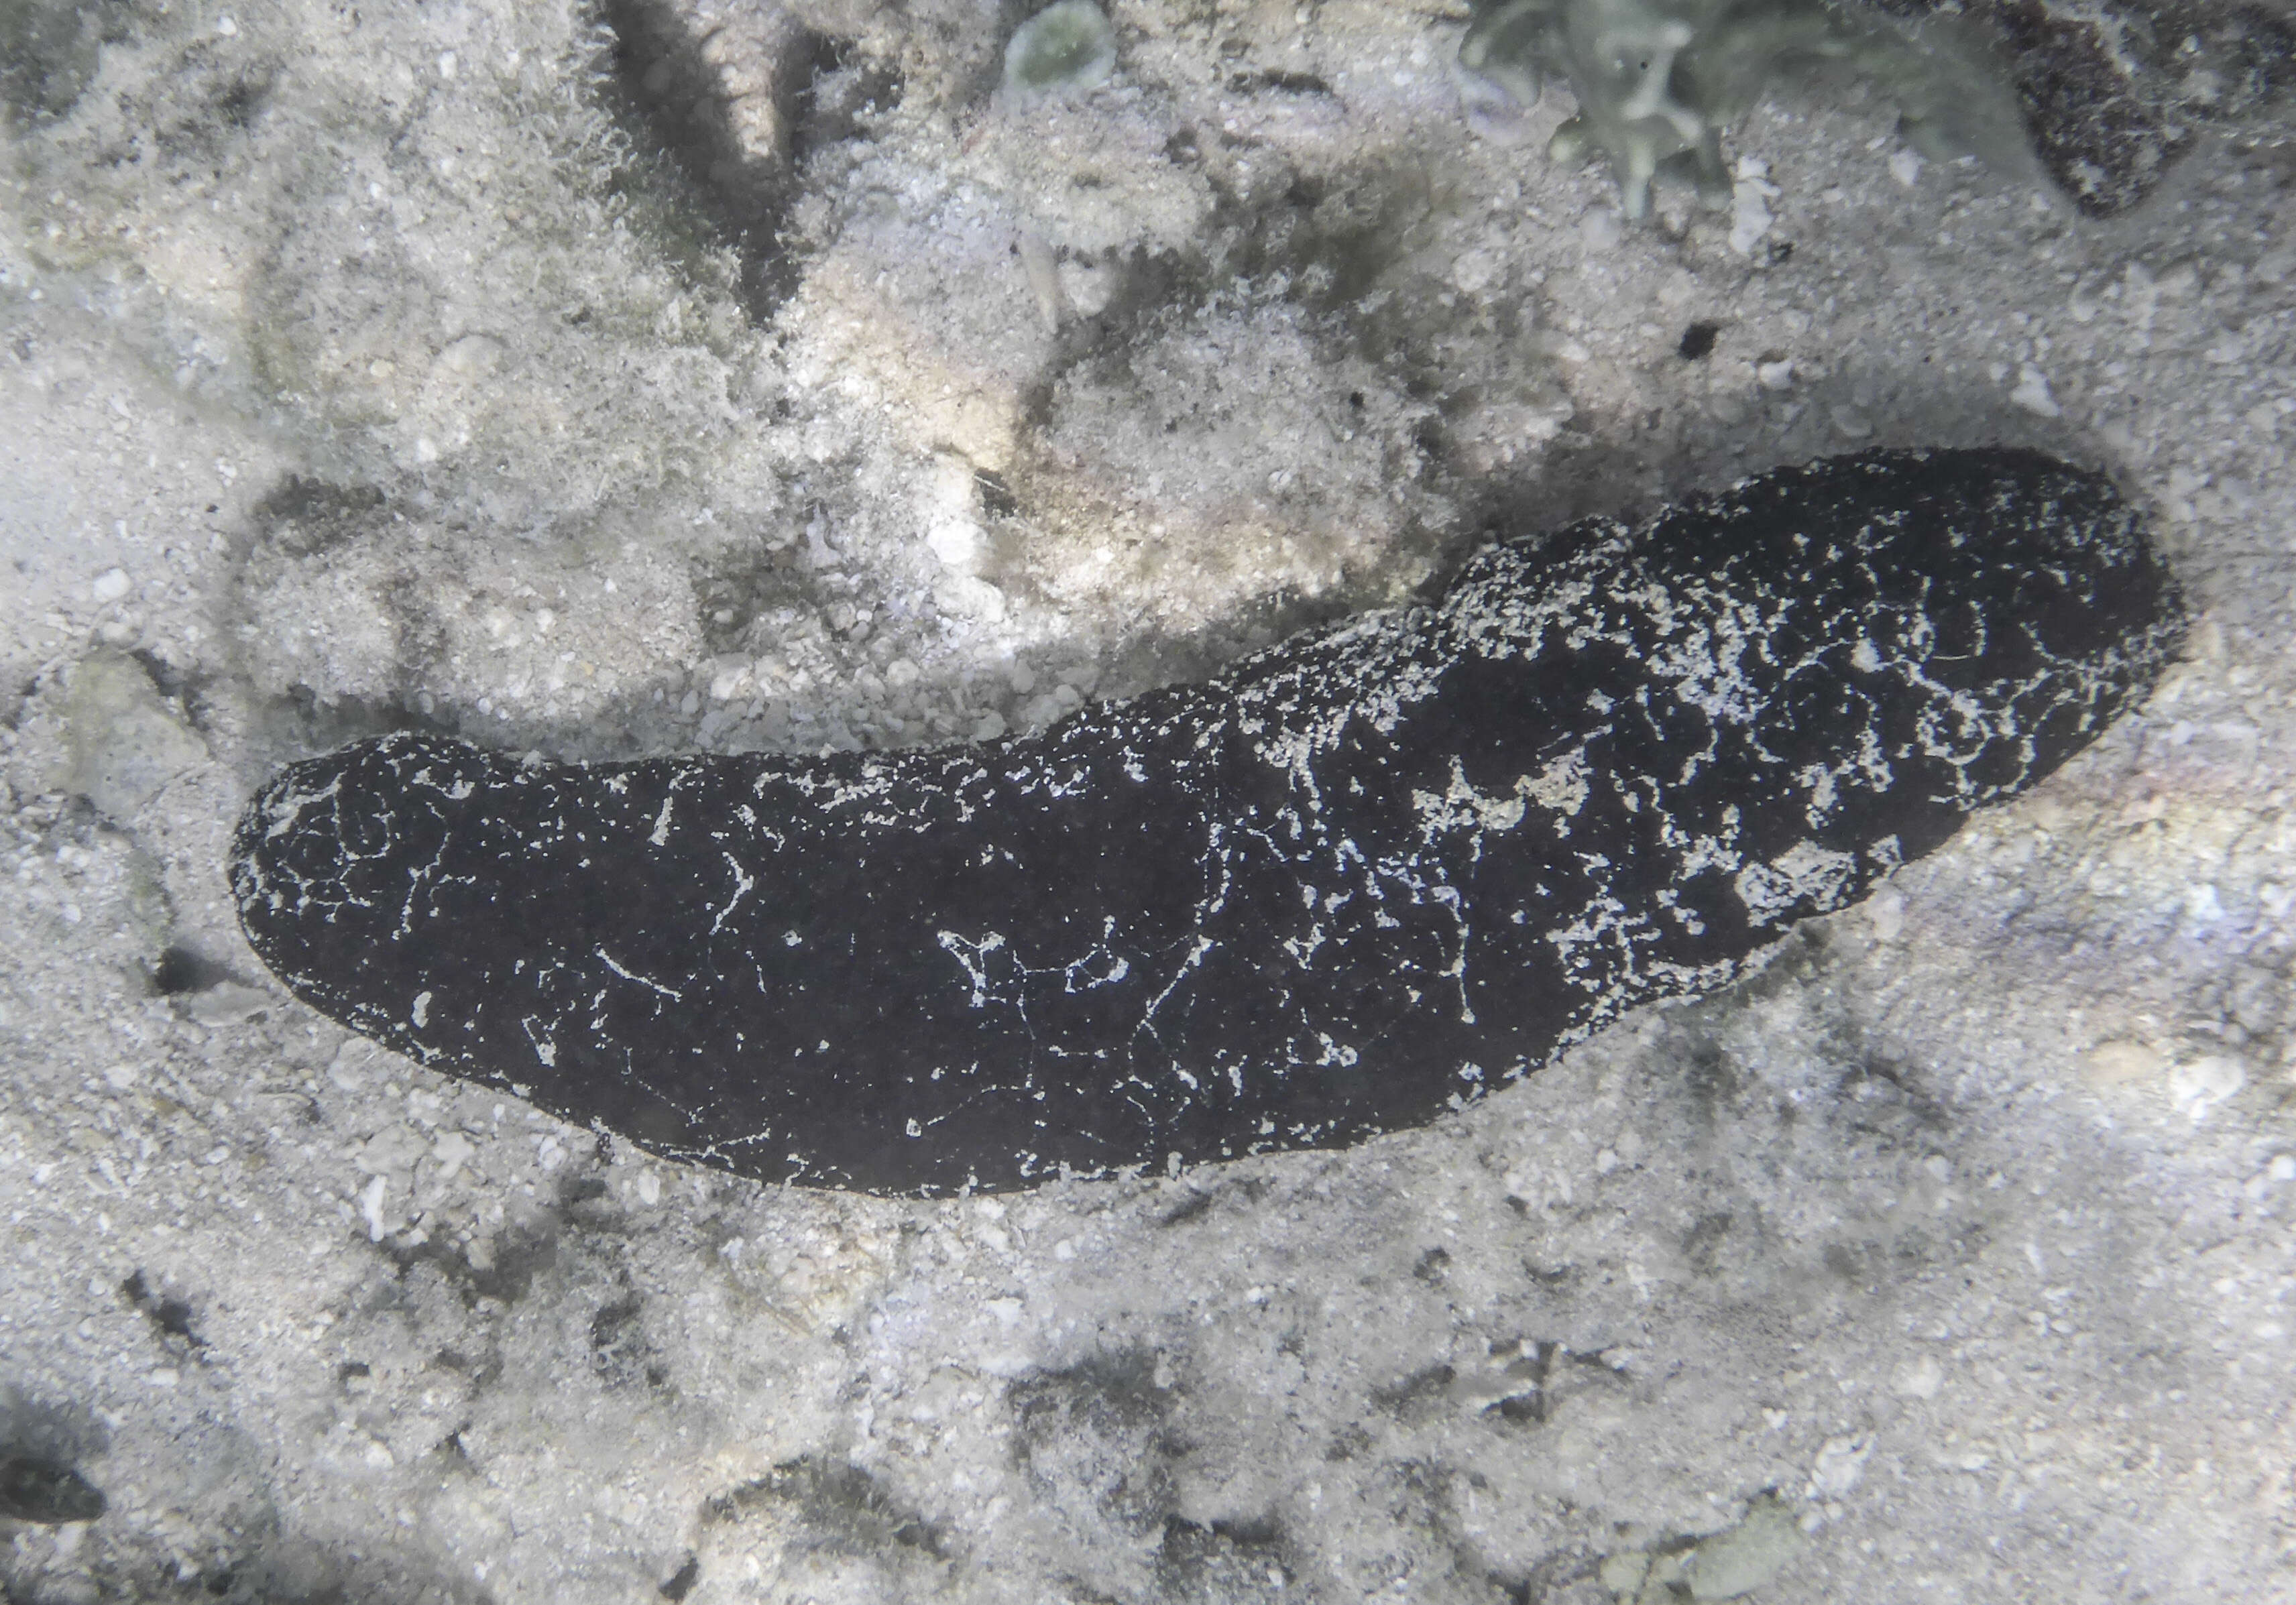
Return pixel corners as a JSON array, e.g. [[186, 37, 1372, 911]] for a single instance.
[[232, 450, 2181, 1194]]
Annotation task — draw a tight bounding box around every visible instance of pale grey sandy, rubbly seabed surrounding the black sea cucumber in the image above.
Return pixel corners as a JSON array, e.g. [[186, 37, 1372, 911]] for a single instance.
[[0, 0, 2296, 1605]]
